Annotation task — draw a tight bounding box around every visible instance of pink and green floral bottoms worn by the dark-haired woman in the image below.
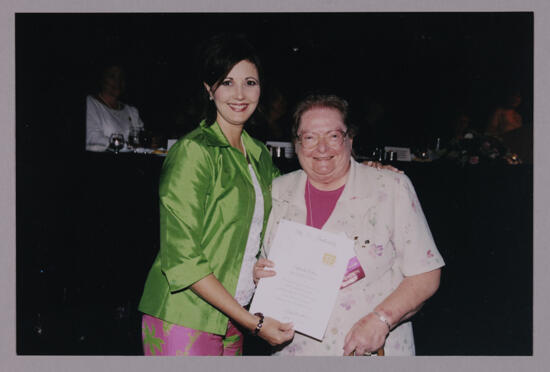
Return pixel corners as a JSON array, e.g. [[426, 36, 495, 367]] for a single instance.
[[141, 314, 243, 356]]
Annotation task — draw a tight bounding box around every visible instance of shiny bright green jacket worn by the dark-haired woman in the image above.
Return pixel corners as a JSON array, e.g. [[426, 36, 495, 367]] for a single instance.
[[138, 122, 279, 335]]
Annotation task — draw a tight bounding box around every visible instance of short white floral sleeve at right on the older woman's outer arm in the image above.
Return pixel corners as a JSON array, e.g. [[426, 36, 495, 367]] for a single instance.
[[394, 175, 444, 276]]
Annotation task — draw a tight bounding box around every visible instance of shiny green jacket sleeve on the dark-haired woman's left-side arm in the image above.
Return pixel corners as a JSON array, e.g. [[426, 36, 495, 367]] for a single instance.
[[159, 139, 213, 292]]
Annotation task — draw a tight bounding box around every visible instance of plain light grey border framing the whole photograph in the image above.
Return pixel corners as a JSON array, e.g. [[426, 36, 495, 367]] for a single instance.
[[0, 0, 550, 372]]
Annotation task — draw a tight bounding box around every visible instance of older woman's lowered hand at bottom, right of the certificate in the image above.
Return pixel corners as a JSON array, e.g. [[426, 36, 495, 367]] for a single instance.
[[344, 313, 389, 356]]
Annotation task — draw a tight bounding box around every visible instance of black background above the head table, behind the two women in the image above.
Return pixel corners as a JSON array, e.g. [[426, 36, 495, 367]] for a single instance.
[[16, 12, 533, 150]]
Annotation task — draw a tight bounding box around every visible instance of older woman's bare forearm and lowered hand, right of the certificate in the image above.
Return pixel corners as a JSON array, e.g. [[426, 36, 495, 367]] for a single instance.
[[344, 269, 441, 355]]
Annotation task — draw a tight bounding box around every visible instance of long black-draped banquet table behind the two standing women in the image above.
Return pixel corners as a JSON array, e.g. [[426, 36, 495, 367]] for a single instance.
[[16, 152, 533, 355]]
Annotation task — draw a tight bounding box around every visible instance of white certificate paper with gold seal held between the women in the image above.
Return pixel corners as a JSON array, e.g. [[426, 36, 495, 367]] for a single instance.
[[250, 220, 355, 340]]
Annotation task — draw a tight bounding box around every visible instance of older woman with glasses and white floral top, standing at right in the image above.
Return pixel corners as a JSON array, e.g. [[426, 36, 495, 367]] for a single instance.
[[254, 95, 444, 355]]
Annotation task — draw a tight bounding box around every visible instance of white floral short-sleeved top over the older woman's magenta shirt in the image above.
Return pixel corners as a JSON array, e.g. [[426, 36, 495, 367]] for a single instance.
[[262, 160, 444, 356]]
